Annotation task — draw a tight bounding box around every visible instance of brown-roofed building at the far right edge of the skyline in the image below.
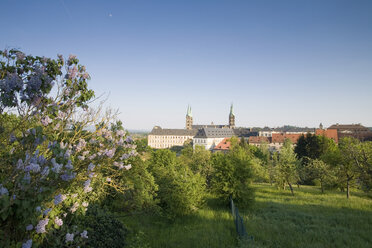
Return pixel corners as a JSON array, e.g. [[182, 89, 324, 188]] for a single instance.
[[327, 123, 372, 141]]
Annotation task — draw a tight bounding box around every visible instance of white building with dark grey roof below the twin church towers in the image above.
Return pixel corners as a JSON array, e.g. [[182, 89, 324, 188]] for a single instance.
[[192, 128, 234, 150]]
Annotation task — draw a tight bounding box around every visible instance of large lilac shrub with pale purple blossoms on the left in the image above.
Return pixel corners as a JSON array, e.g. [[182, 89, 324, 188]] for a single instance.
[[0, 50, 137, 247]]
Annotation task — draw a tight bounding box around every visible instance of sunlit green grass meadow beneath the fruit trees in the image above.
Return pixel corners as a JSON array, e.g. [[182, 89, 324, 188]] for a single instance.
[[122, 184, 372, 248]]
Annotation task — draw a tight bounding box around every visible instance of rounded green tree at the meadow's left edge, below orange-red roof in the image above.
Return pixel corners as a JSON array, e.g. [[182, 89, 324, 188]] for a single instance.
[[211, 146, 254, 207]]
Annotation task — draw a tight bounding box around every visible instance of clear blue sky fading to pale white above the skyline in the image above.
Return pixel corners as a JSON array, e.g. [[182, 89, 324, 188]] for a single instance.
[[0, 0, 372, 130]]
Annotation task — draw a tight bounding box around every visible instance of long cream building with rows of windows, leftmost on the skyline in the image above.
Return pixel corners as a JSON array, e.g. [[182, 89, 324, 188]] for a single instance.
[[148, 126, 198, 149]]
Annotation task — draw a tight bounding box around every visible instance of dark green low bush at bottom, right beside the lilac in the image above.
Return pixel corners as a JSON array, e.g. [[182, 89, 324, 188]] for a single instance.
[[82, 205, 128, 248]]
